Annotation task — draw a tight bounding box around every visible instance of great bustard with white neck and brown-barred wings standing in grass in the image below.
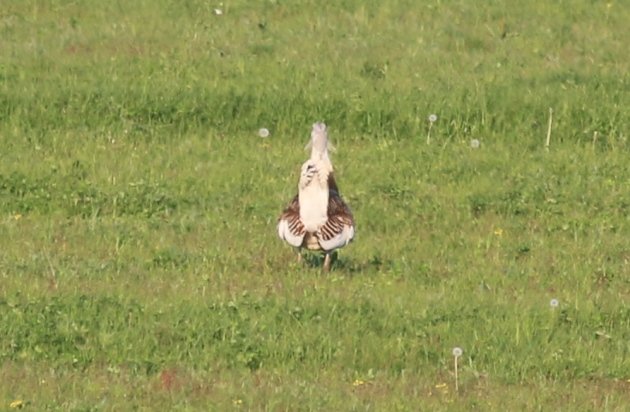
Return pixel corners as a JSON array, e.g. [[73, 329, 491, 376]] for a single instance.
[[278, 123, 354, 271]]
